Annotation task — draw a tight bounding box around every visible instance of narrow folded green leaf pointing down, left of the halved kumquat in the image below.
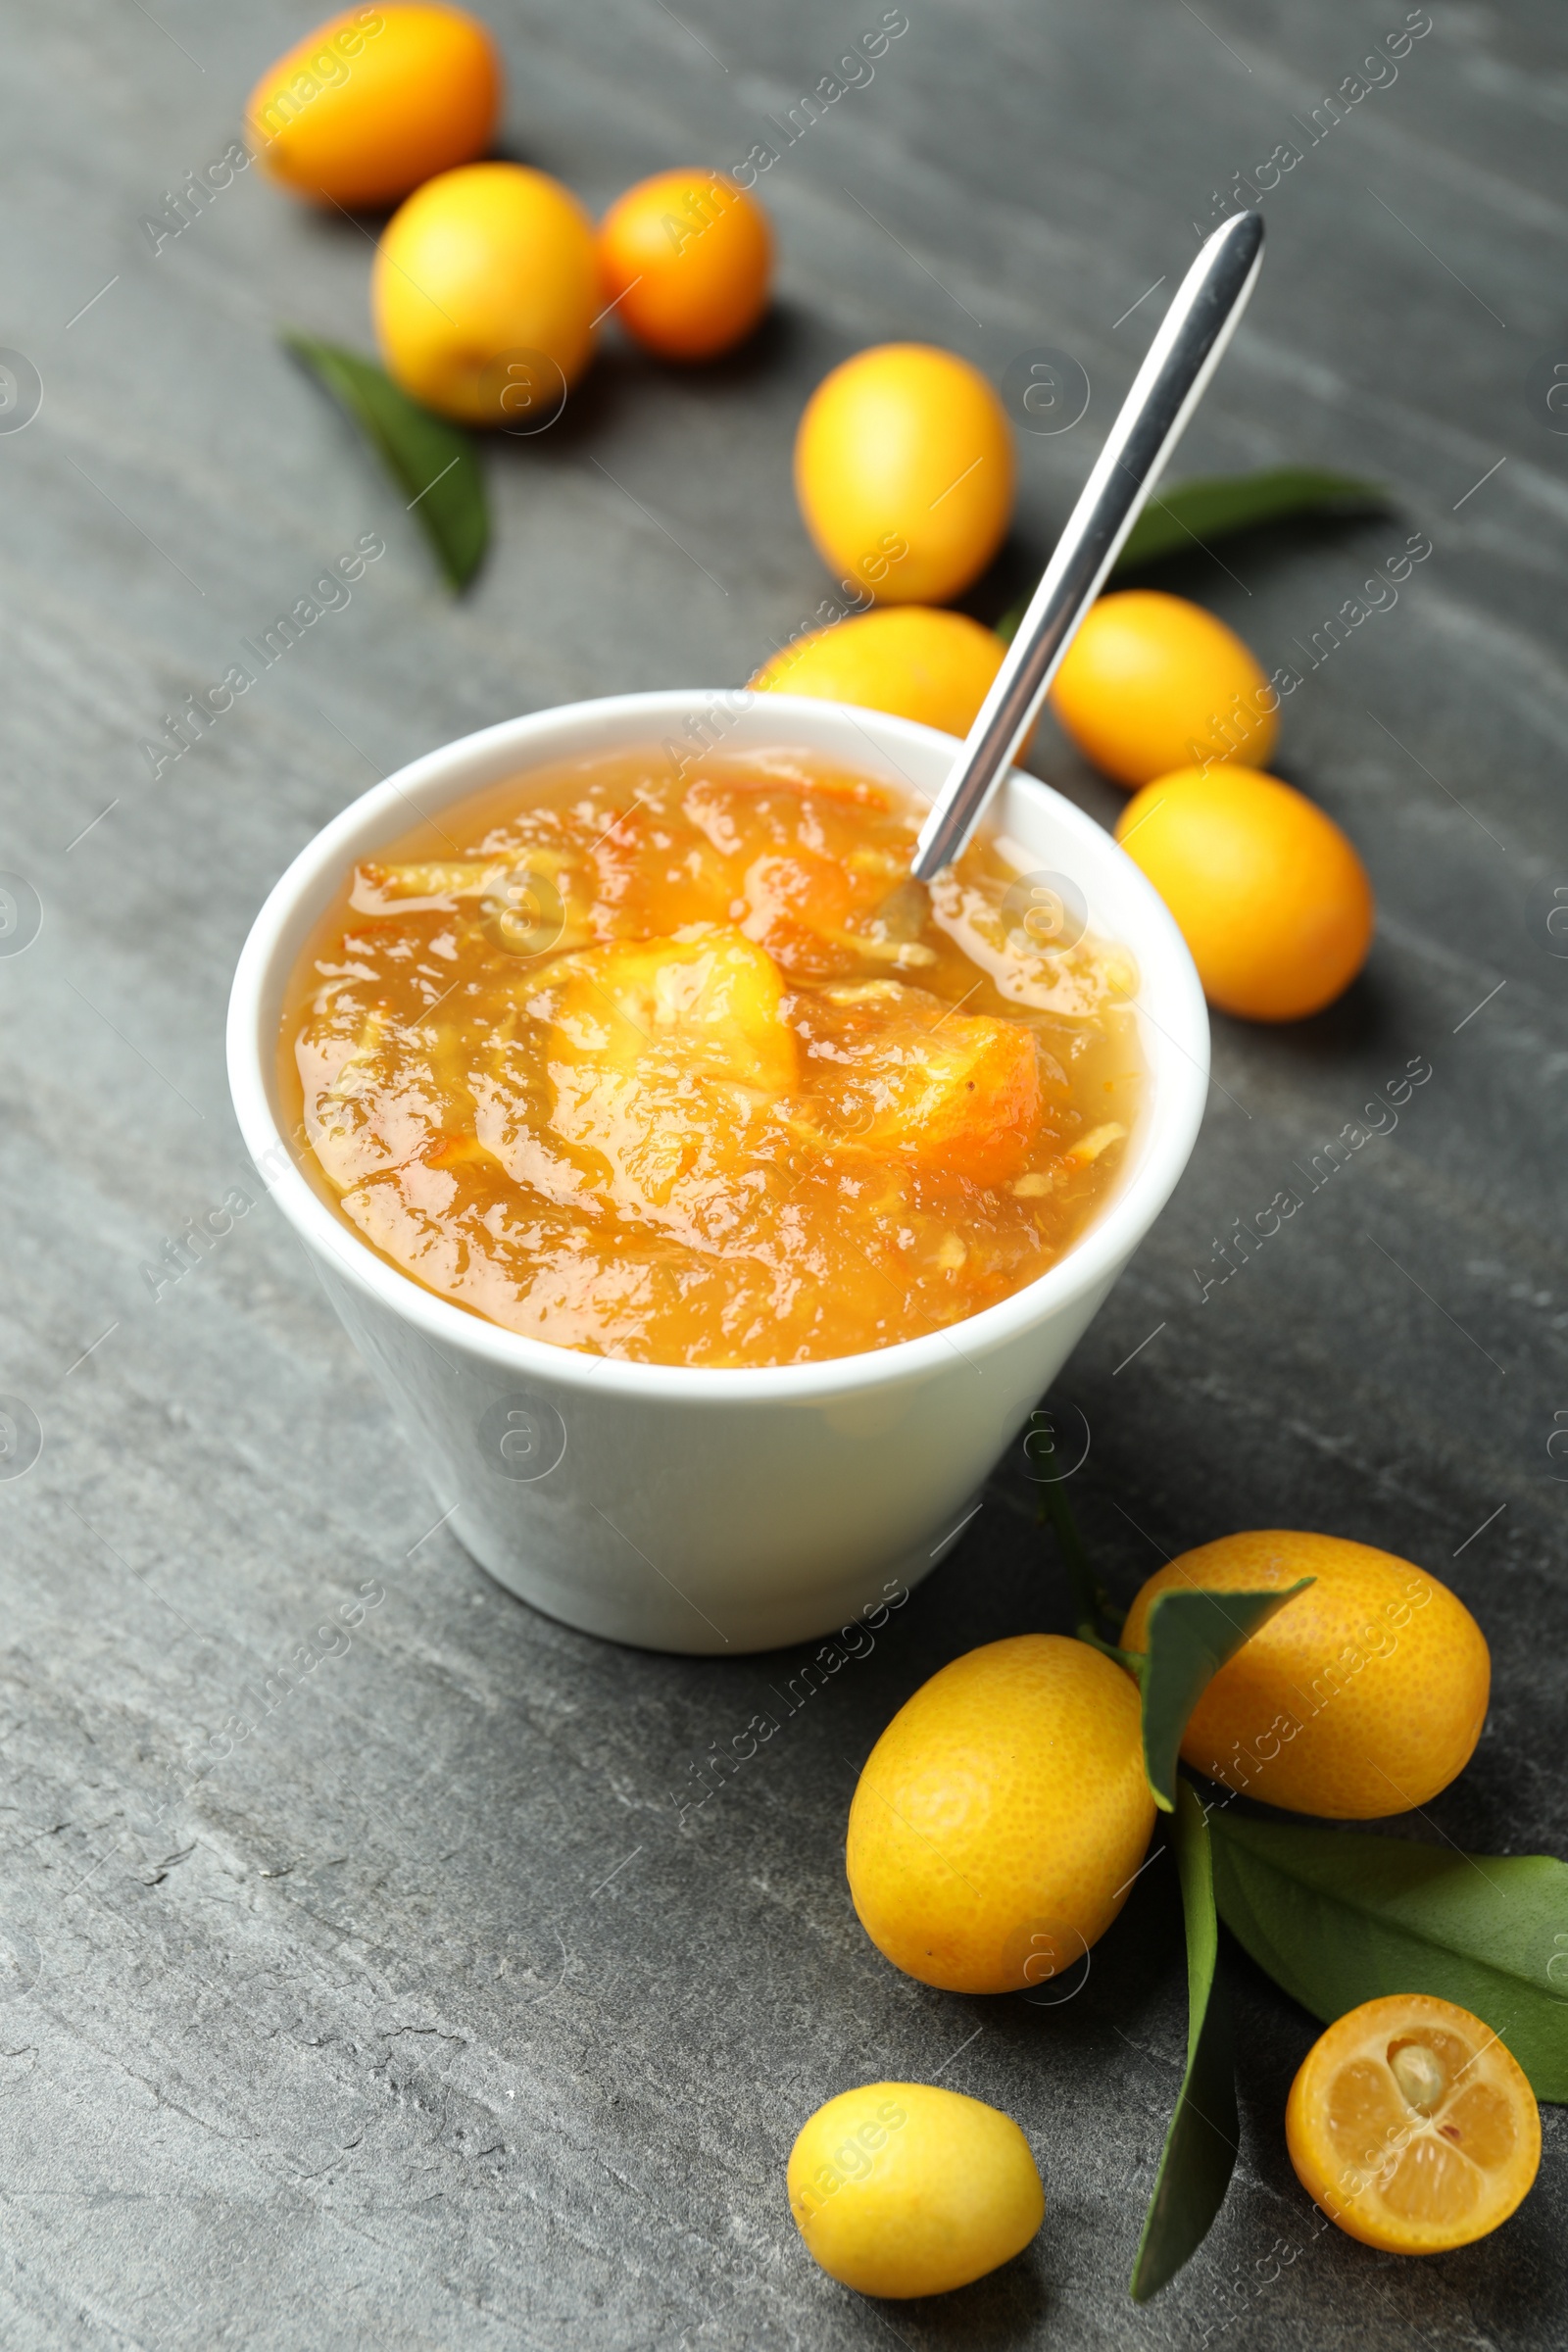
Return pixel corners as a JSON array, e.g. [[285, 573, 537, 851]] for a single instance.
[[1128, 1781, 1242, 2303]]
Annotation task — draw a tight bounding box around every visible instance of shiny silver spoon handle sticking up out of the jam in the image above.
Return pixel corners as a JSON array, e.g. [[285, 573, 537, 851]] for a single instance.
[[909, 212, 1262, 882]]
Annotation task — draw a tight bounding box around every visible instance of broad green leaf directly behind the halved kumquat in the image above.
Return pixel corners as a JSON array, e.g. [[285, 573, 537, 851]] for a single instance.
[[1210, 1809, 1568, 2105]]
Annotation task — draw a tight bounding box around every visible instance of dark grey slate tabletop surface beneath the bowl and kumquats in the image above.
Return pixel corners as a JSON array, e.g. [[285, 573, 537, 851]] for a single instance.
[[0, 0, 1568, 2352]]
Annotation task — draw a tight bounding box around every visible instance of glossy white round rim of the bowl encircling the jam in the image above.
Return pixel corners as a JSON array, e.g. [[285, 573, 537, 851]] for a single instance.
[[225, 687, 1208, 1406]]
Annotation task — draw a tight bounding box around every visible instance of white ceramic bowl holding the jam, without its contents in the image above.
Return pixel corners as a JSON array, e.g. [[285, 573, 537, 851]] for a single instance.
[[228, 689, 1208, 1653]]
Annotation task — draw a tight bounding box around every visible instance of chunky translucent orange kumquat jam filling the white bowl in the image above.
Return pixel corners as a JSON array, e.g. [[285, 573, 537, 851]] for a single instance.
[[279, 746, 1143, 1366]]
